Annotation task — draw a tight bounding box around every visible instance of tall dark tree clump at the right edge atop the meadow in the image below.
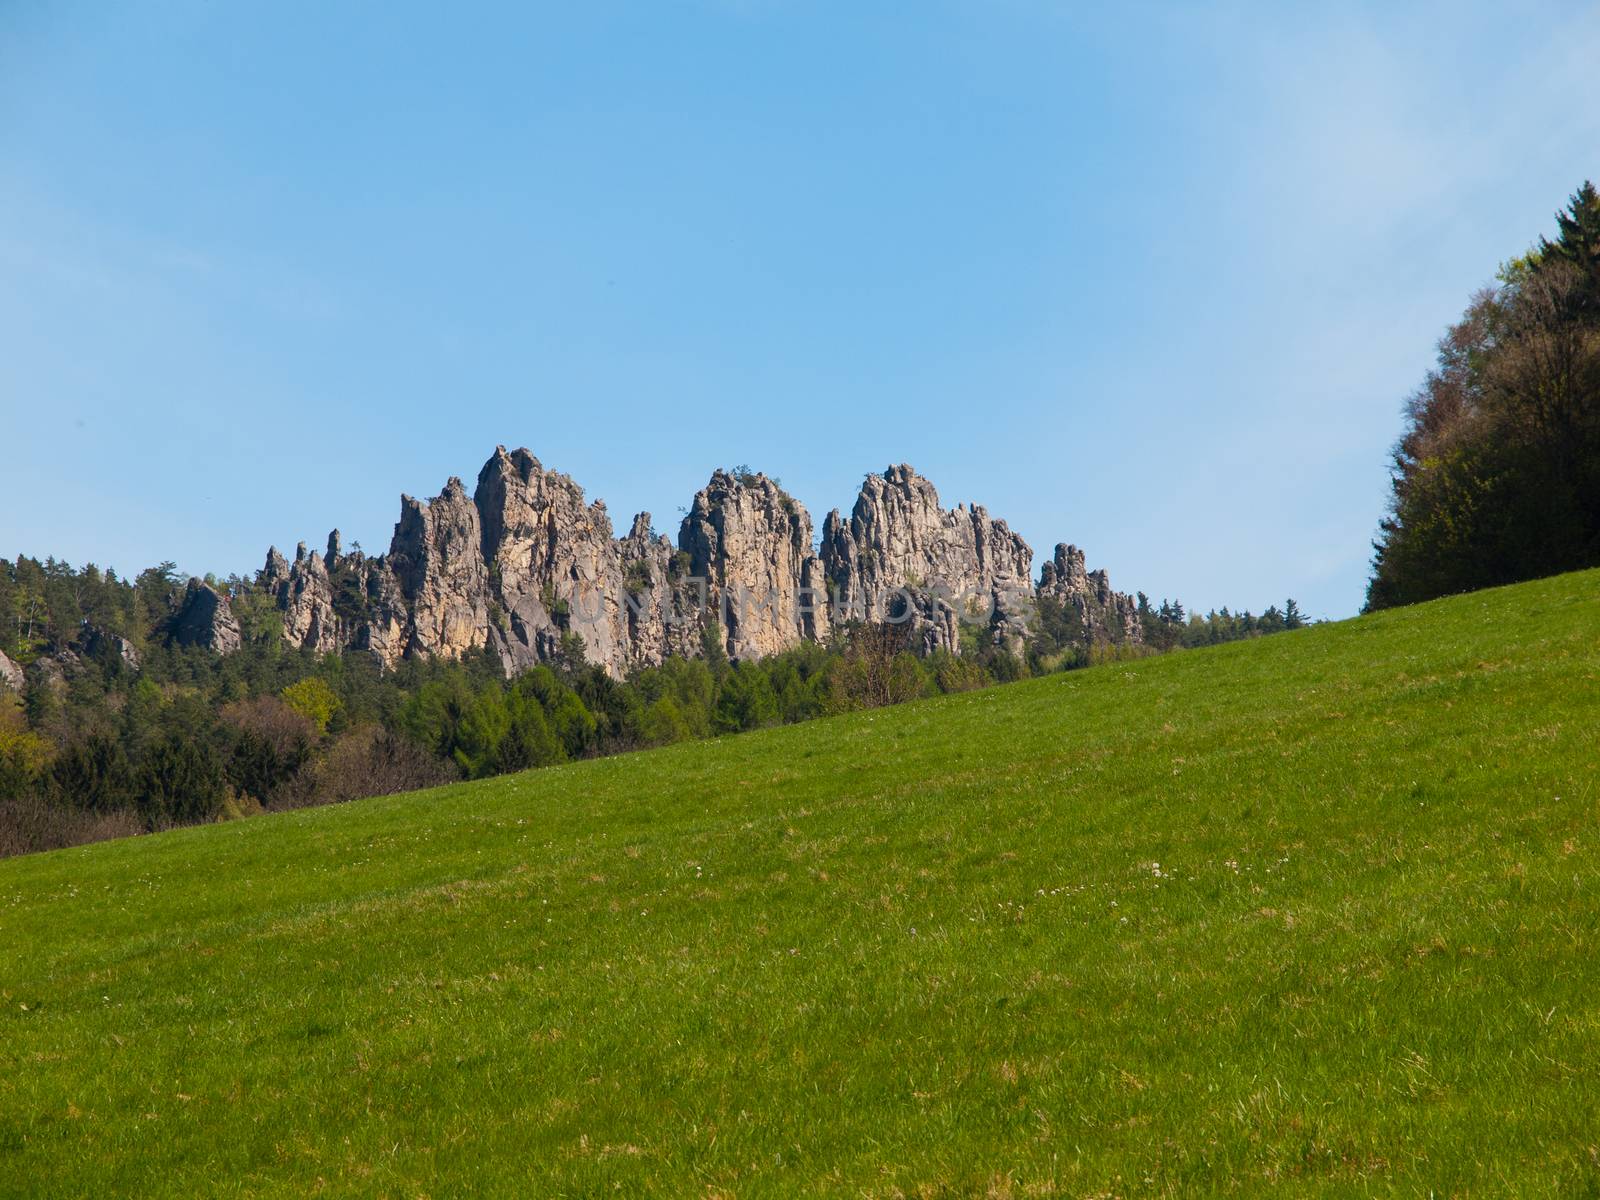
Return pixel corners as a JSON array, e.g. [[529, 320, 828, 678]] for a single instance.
[[1366, 184, 1600, 610]]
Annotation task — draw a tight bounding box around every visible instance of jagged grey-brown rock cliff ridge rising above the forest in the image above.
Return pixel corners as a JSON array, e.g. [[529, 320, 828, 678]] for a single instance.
[[259, 446, 1139, 677]]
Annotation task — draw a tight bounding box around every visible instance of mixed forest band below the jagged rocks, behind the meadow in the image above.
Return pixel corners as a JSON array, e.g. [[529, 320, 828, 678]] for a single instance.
[[0, 557, 1302, 854]]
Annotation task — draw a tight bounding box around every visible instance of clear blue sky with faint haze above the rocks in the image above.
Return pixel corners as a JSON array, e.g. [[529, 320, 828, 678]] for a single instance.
[[0, 0, 1600, 616]]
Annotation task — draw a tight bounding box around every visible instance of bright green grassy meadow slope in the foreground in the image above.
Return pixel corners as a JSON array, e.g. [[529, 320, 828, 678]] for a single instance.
[[0, 573, 1600, 1197]]
